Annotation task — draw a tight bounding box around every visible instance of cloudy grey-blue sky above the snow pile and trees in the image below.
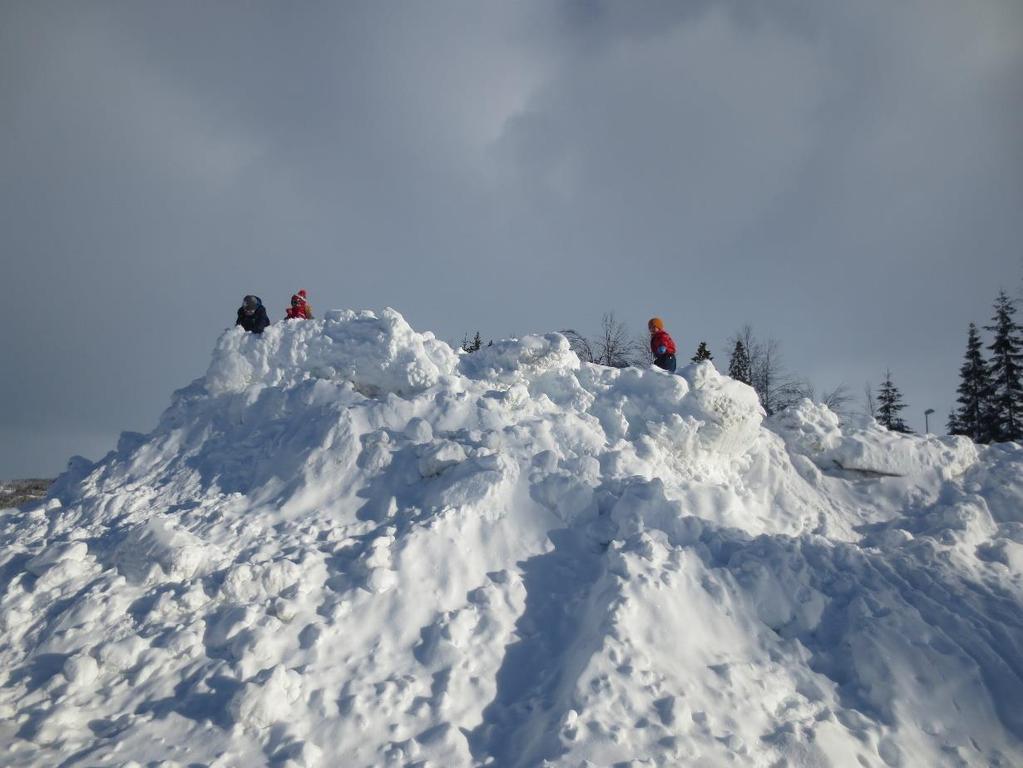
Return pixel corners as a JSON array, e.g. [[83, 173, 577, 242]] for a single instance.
[[0, 0, 1023, 478]]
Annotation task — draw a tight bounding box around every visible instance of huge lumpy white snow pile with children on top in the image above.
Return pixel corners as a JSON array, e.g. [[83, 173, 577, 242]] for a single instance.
[[0, 310, 1023, 767]]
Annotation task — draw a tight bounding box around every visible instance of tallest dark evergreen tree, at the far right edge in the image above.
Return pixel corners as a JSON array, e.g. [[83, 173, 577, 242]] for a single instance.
[[984, 290, 1023, 441]]
